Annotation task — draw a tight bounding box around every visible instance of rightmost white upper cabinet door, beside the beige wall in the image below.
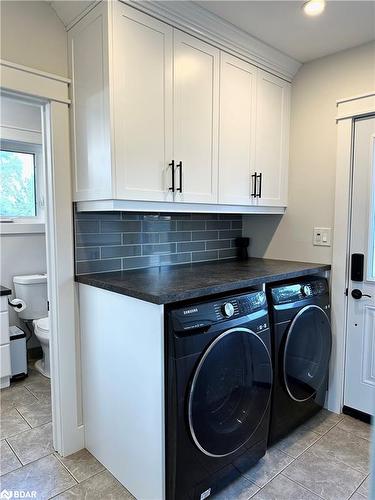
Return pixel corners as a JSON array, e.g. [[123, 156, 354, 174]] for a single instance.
[[255, 70, 290, 206]]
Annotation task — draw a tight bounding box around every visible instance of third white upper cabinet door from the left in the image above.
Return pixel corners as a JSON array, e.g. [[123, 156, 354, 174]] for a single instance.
[[219, 52, 257, 205]]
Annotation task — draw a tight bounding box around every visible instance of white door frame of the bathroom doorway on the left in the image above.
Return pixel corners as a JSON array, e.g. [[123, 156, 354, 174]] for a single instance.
[[0, 60, 84, 456]]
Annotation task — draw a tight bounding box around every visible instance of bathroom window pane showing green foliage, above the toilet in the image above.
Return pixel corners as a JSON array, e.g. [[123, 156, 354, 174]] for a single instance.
[[0, 149, 36, 217]]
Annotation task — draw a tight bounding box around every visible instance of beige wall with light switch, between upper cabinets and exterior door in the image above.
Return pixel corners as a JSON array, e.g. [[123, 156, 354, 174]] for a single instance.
[[244, 43, 375, 263]]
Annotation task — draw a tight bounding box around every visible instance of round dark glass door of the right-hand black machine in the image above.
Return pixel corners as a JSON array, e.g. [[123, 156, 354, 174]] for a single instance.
[[284, 305, 332, 402]]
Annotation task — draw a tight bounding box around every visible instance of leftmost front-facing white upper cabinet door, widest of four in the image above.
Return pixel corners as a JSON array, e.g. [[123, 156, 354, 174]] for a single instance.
[[112, 2, 173, 201]]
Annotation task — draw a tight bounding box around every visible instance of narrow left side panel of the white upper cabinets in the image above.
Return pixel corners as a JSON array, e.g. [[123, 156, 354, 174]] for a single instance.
[[69, 2, 113, 201]]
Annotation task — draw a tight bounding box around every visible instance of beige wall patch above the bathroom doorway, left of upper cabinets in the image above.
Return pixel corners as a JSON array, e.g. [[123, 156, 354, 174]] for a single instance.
[[0, 0, 68, 76]]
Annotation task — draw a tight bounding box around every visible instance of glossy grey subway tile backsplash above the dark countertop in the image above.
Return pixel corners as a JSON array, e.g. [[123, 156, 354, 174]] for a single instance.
[[75, 212, 242, 274]]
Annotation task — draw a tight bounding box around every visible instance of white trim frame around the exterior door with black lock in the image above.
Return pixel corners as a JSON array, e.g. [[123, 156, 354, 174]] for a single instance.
[[327, 91, 375, 413]]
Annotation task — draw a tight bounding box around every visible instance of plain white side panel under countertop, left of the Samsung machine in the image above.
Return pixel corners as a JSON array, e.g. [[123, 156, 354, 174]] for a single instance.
[[79, 284, 165, 500]]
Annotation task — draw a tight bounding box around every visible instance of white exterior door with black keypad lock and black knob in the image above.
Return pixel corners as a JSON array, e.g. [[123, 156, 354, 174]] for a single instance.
[[344, 117, 375, 414]]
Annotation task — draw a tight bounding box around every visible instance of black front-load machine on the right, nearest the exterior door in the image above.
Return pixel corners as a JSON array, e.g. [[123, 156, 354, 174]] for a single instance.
[[267, 277, 332, 444]]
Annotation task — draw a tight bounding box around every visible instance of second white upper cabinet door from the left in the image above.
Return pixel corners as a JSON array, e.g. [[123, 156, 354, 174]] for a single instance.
[[173, 30, 219, 203]]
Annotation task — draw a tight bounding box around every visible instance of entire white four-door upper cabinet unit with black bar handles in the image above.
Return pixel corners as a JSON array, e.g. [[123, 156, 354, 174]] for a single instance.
[[69, 2, 290, 211]]
